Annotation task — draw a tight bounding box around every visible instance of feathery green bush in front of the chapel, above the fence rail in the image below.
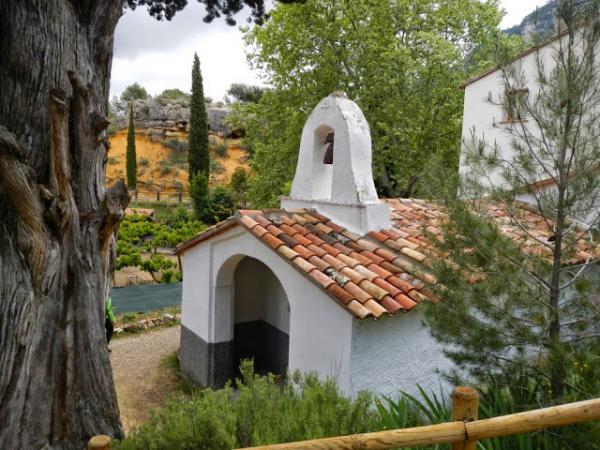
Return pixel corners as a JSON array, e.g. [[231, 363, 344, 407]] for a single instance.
[[115, 361, 377, 450]]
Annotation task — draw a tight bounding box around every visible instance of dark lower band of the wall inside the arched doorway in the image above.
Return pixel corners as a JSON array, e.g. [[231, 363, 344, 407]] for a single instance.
[[233, 320, 290, 376]]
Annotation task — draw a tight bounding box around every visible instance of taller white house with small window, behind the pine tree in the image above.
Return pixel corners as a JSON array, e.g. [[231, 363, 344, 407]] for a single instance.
[[459, 27, 600, 225]]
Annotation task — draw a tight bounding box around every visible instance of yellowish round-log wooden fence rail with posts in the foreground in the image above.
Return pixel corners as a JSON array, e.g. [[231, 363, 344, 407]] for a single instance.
[[88, 387, 600, 450]]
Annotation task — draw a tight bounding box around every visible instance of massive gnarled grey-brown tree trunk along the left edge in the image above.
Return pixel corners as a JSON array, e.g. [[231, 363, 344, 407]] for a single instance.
[[0, 0, 129, 449]]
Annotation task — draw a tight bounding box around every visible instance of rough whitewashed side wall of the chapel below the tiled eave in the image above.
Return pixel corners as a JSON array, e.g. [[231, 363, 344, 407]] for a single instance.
[[351, 307, 453, 397]]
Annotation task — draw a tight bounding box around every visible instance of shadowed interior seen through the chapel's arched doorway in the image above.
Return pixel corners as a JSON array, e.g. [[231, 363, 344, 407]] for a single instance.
[[232, 256, 290, 375]]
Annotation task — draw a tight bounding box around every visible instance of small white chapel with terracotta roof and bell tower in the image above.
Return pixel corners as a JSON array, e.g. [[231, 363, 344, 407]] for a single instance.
[[178, 93, 596, 395]]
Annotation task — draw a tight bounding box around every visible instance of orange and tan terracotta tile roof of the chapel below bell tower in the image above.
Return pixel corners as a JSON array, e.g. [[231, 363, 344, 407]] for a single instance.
[[178, 199, 600, 319]]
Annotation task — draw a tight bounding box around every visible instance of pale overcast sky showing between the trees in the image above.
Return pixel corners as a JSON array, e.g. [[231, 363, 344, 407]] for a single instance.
[[111, 0, 547, 100]]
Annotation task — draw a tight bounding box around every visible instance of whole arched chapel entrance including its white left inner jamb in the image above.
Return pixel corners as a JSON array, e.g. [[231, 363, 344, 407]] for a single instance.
[[212, 254, 290, 381]]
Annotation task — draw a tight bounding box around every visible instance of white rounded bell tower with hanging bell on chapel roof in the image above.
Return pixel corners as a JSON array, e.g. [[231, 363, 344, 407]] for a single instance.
[[281, 92, 391, 234]]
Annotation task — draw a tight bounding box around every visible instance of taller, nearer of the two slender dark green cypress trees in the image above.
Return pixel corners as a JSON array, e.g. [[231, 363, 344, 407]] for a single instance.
[[188, 53, 210, 181]]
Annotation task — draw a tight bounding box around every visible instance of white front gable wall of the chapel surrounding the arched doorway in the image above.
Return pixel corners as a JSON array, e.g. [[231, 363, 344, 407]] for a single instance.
[[181, 227, 353, 393]]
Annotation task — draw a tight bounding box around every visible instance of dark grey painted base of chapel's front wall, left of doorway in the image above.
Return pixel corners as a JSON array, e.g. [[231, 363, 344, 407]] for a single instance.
[[179, 325, 233, 388]]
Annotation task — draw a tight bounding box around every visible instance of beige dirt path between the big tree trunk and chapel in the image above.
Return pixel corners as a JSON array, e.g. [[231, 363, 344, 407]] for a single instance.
[[110, 326, 180, 433]]
